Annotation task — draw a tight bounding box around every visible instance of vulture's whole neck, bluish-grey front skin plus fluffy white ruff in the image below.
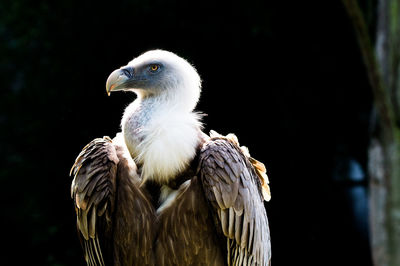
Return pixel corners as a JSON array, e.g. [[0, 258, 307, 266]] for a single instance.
[[121, 91, 201, 184]]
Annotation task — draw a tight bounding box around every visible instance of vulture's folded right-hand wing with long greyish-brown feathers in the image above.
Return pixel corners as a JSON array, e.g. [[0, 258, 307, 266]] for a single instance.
[[200, 135, 271, 265]]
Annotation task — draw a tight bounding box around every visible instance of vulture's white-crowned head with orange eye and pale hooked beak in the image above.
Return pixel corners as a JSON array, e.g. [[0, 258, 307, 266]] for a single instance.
[[106, 50, 201, 111]]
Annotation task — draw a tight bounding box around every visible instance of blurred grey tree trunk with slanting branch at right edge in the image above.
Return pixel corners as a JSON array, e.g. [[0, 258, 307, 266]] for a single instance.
[[343, 0, 400, 266]]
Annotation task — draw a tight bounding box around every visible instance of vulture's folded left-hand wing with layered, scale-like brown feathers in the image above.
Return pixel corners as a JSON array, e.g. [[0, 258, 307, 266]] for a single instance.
[[71, 137, 119, 265]]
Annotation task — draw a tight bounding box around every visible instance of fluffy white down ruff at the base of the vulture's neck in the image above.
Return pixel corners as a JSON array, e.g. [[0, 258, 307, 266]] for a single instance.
[[136, 111, 201, 183]]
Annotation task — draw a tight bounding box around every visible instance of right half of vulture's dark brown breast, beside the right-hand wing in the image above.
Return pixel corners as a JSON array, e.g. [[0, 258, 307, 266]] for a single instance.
[[156, 176, 225, 266]]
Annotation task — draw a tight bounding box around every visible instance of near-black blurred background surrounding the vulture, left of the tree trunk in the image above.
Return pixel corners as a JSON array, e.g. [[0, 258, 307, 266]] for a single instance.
[[0, 0, 375, 266]]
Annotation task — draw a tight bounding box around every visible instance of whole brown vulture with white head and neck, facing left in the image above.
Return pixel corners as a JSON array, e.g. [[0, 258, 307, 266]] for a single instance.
[[70, 50, 271, 266]]
